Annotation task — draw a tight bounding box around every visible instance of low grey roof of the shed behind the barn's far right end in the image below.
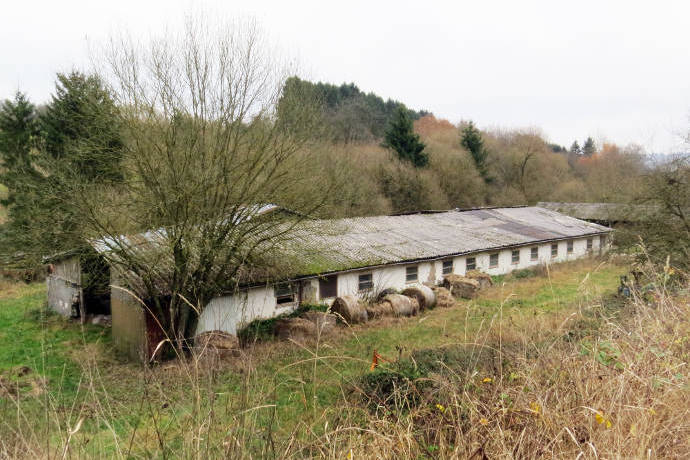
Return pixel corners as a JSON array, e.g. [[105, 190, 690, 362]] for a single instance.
[[537, 201, 660, 222]]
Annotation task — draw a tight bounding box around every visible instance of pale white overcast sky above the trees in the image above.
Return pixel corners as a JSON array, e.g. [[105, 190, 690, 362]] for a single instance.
[[0, 0, 690, 153]]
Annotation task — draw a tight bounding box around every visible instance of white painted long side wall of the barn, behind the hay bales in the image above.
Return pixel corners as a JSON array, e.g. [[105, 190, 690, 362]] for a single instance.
[[197, 236, 611, 335]]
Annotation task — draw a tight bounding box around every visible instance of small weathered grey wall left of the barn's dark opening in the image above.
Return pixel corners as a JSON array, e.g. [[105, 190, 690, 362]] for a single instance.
[[46, 257, 82, 316]]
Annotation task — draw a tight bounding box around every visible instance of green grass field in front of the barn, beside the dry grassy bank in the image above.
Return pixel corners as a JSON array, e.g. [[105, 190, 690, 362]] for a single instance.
[[0, 260, 684, 458]]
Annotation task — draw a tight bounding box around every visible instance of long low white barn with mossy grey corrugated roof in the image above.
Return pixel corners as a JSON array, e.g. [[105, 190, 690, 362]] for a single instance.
[[48, 207, 611, 360]]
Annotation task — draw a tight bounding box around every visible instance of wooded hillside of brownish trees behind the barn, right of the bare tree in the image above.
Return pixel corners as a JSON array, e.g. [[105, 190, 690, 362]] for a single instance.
[[285, 77, 650, 216]]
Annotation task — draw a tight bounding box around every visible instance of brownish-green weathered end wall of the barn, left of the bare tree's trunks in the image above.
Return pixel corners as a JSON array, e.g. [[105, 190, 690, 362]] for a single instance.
[[110, 270, 148, 361]]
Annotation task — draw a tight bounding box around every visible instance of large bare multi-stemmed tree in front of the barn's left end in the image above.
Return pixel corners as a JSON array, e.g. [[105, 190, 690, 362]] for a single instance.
[[75, 16, 329, 347]]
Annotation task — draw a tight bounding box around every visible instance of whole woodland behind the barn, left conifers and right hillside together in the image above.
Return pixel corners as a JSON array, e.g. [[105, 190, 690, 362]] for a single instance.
[[0, 72, 684, 270]]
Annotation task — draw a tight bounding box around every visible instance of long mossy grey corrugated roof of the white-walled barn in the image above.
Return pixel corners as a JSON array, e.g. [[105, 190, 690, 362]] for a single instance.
[[290, 207, 610, 275]]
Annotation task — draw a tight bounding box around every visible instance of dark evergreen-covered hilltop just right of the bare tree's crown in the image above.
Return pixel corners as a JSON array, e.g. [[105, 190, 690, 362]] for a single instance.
[[283, 77, 431, 142]]
